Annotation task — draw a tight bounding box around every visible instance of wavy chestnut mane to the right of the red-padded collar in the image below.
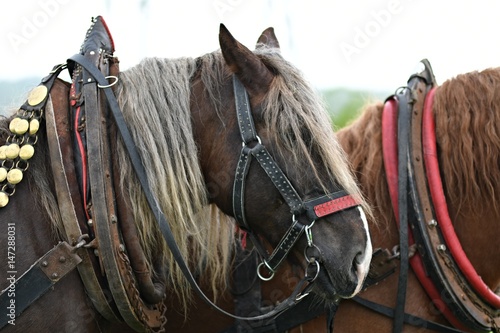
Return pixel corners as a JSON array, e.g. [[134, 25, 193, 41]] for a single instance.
[[433, 68, 500, 218]]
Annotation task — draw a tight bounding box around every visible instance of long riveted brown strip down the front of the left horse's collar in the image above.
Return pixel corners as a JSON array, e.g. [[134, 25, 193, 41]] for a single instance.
[[83, 55, 163, 332]]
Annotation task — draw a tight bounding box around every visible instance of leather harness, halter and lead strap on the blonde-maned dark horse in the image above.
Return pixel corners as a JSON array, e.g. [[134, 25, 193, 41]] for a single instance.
[[0, 16, 366, 332]]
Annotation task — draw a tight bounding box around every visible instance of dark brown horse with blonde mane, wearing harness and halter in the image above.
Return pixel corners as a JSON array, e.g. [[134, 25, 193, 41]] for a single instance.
[[0, 17, 371, 333]]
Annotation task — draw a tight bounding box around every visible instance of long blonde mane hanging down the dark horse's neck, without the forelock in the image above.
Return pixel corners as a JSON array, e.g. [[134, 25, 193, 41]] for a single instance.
[[113, 58, 234, 304]]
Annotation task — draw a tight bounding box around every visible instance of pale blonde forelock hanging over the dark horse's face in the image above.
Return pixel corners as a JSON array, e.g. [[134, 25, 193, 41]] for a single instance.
[[257, 48, 371, 215]]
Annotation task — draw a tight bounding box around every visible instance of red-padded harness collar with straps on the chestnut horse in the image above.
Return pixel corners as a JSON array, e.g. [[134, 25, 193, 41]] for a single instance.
[[354, 59, 500, 332]]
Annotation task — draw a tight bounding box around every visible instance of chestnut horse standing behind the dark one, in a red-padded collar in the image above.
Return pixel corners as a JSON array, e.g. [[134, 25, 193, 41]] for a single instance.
[[244, 63, 500, 333]]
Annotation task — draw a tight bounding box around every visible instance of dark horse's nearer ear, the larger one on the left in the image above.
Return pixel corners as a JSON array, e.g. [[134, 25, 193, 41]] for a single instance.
[[219, 24, 274, 96]]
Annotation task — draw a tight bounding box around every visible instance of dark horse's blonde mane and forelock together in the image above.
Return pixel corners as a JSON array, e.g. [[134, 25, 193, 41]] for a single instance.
[[113, 49, 368, 308]]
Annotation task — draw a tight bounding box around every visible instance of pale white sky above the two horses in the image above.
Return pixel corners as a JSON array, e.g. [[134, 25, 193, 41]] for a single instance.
[[0, 0, 500, 92]]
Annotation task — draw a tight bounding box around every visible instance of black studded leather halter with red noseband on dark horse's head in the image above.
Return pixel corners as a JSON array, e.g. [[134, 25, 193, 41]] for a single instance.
[[233, 75, 359, 280]]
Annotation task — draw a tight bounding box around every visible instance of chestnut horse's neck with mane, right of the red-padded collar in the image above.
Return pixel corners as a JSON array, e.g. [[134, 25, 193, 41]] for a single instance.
[[433, 79, 500, 290]]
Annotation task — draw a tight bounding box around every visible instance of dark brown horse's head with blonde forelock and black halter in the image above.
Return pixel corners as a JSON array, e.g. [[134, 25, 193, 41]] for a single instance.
[[191, 25, 372, 299]]
